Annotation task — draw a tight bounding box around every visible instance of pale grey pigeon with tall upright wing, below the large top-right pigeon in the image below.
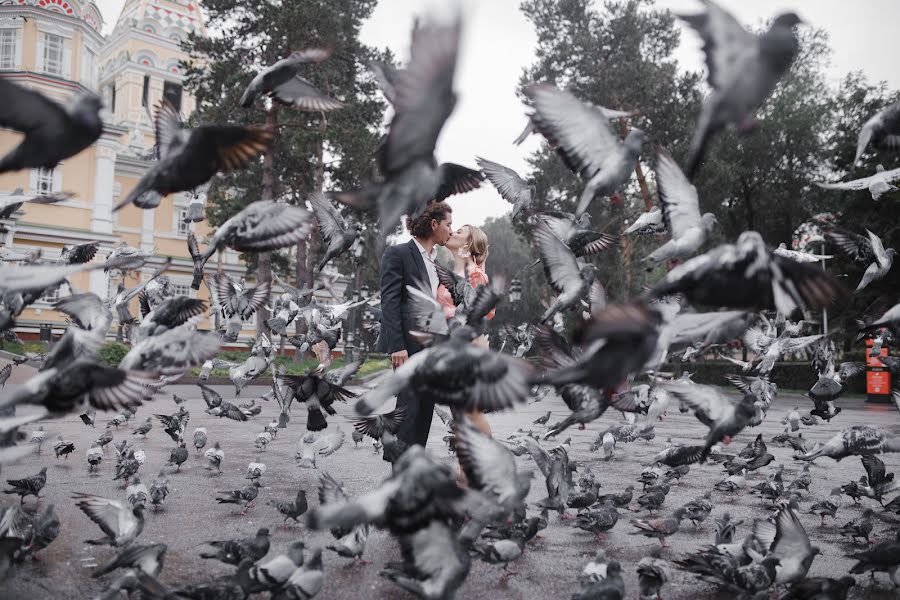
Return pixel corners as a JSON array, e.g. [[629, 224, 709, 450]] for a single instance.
[[643, 148, 718, 268]]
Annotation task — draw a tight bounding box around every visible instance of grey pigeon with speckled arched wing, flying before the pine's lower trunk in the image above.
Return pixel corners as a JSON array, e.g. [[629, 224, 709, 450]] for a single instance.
[[188, 200, 312, 290]]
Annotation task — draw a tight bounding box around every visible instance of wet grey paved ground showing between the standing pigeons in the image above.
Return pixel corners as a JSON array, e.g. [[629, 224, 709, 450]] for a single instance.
[[0, 368, 900, 600]]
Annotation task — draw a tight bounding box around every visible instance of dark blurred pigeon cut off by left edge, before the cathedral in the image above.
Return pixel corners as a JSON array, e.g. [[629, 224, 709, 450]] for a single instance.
[[0, 79, 103, 173]]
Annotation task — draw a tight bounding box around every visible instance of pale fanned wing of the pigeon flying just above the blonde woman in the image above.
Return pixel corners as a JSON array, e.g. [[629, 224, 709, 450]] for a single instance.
[[524, 84, 621, 178]]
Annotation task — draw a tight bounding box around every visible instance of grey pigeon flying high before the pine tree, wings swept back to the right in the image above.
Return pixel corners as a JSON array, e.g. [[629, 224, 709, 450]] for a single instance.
[[238, 48, 344, 112]]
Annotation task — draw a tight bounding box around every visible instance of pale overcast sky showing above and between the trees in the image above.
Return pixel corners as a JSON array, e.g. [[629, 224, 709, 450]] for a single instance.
[[97, 0, 900, 225]]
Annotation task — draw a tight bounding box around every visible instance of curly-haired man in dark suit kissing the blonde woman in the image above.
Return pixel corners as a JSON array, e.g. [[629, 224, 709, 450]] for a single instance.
[[378, 202, 453, 446]]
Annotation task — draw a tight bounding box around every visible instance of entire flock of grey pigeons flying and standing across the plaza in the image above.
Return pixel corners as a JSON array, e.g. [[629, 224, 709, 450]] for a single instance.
[[0, 0, 900, 599]]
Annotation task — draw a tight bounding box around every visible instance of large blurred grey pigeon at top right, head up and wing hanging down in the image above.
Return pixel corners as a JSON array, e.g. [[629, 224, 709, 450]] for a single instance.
[[678, 0, 803, 179]]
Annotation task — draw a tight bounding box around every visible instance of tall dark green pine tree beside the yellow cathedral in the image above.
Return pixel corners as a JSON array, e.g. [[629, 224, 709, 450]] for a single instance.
[[185, 0, 391, 331]]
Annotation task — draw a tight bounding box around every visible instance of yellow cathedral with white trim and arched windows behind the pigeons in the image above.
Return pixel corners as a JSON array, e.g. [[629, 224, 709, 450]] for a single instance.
[[0, 0, 264, 340]]
